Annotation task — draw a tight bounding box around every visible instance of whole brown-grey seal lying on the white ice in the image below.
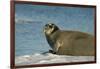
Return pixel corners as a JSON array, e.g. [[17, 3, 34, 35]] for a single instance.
[[44, 23, 95, 56]]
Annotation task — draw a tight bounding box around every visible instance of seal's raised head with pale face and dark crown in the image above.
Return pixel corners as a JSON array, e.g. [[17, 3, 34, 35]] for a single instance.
[[44, 23, 59, 35]]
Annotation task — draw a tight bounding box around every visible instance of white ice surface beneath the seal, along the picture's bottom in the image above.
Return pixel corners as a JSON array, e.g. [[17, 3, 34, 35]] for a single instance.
[[15, 53, 94, 65]]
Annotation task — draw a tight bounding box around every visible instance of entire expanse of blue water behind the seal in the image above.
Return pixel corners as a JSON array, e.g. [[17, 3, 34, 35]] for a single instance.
[[15, 4, 94, 56]]
